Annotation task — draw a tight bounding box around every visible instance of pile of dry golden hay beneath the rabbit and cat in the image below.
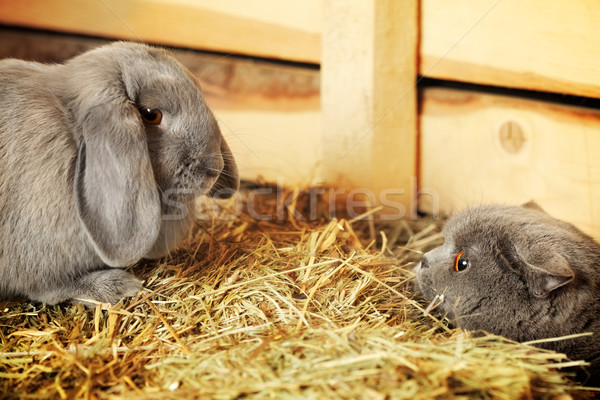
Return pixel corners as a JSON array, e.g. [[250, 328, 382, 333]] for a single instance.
[[0, 186, 586, 399]]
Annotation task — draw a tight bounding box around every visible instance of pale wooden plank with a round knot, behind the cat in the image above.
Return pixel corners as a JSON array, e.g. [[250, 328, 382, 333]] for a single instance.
[[420, 88, 600, 239]]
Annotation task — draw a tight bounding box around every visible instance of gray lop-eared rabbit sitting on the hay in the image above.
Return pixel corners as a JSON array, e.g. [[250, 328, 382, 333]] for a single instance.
[[0, 42, 238, 305]]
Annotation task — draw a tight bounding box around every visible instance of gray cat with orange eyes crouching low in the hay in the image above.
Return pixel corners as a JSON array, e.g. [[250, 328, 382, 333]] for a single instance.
[[416, 203, 600, 384]]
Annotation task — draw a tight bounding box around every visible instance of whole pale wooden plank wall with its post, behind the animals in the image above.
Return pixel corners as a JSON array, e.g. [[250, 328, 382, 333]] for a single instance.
[[0, 0, 600, 238]]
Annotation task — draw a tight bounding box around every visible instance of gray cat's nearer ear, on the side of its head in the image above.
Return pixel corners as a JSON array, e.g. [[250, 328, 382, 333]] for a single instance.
[[515, 245, 575, 297]]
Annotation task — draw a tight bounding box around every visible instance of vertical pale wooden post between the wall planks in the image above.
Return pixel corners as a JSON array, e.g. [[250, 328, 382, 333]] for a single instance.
[[321, 0, 419, 217]]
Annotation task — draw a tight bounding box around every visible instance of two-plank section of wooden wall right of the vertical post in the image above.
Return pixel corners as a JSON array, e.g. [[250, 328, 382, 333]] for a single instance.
[[420, 0, 600, 238]]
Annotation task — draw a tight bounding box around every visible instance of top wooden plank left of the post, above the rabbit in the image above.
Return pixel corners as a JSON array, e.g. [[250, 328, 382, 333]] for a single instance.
[[0, 0, 321, 63]]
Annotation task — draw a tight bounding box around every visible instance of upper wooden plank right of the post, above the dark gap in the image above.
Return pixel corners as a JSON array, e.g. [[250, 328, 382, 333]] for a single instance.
[[420, 0, 600, 97]]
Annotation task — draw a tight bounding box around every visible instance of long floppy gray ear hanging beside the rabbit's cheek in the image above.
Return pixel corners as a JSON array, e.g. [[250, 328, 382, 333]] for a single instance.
[[75, 85, 161, 266]]
